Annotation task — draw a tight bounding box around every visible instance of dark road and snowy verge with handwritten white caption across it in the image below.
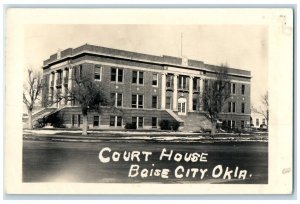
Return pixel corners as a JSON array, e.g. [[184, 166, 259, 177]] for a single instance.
[[23, 131, 268, 184]]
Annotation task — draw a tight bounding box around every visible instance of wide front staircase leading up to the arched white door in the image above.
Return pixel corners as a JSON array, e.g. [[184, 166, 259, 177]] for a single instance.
[[180, 112, 211, 132]]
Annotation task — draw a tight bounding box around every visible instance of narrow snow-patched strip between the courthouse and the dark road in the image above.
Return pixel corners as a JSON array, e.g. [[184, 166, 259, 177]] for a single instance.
[[23, 129, 268, 143]]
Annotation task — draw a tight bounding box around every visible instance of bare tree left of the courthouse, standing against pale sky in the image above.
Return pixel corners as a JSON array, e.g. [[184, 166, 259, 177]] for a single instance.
[[23, 68, 43, 129]]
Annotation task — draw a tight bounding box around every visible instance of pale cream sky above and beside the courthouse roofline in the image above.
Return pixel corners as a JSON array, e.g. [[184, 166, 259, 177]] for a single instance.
[[24, 24, 268, 106]]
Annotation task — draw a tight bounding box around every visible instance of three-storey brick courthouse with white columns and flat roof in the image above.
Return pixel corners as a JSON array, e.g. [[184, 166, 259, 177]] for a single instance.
[[39, 44, 251, 131]]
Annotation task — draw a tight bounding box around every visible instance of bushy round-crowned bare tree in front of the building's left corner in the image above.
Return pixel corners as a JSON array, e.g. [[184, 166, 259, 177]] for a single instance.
[[66, 77, 109, 135]]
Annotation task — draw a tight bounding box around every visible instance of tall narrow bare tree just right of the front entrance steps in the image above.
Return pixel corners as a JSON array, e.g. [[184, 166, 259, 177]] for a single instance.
[[201, 65, 231, 135]]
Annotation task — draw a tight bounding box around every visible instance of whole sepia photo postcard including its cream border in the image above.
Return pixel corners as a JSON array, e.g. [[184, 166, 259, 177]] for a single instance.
[[6, 8, 293, 194]]
